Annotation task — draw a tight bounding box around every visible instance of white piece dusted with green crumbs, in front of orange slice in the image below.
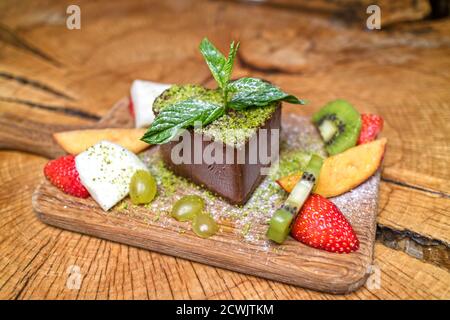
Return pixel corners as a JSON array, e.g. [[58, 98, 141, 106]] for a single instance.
[[75, 141, 148, 211]]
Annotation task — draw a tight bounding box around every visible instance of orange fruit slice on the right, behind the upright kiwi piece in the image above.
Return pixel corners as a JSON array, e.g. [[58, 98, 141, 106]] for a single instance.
[[277, 138, 387, 198]]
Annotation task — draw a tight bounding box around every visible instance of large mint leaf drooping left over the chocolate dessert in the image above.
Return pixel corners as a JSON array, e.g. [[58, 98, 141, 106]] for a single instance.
[[141, 99, 225, 144]]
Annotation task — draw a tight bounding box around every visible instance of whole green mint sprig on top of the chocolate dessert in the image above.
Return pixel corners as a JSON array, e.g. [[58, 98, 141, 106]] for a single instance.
[[141, 38, 305, 144]]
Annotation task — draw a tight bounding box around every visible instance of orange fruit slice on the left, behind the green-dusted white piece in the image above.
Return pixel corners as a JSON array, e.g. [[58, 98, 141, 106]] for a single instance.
[[53, 128, 149, 154]]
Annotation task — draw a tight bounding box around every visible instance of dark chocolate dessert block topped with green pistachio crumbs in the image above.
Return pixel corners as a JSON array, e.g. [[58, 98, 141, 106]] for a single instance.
[[154, 86, 281, 205]]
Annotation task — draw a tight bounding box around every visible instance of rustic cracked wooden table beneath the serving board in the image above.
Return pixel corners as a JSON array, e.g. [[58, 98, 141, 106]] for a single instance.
[[0, 0, 450, 299]]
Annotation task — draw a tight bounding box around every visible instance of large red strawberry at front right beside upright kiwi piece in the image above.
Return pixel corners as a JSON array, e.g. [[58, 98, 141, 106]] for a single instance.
[[291, 194, 359, 253]]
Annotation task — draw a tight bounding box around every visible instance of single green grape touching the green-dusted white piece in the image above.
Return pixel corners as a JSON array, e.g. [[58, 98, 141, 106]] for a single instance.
[[130, 170, 156, 204]]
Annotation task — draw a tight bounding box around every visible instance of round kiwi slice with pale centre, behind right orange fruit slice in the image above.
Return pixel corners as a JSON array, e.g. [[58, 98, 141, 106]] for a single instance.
[[312, 100, 361, 155]]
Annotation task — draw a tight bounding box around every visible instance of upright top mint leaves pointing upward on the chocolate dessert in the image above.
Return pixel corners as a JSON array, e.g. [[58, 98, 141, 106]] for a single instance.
[[199, 38, 239, 94]]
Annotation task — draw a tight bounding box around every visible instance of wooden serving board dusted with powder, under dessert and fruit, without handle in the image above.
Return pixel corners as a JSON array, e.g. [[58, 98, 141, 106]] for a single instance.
[[28, 99, 380, 293]]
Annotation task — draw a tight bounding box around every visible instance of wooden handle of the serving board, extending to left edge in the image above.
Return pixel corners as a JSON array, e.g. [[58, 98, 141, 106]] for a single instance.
[[0, 98, 133, 158]]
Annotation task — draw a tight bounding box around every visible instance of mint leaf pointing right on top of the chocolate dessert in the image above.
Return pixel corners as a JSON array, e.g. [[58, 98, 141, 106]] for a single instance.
[[228, 78, 305, 110]]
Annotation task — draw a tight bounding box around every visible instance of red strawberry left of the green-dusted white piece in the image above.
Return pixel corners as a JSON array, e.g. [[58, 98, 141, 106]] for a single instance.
[[44, 155, 89, 198]]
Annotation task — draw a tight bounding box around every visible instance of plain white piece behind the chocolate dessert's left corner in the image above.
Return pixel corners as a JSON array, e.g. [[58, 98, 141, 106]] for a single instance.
[[130, 80, 170, 128]]
